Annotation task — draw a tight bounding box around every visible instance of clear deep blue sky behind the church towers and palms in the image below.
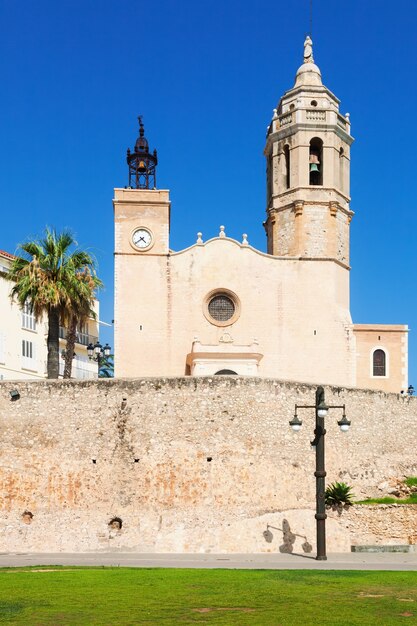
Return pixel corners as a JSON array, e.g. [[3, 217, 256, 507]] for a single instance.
[[0, 0, 417, 387]]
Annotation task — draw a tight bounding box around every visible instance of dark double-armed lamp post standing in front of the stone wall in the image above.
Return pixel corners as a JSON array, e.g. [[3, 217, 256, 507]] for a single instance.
[[290, 387, 350, 561]]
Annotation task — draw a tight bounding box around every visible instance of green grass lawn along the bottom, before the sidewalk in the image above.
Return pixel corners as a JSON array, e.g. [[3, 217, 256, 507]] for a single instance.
[[0, 567, 417, 626]]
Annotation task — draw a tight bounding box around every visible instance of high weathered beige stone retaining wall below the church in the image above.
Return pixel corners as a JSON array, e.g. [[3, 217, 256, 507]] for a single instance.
[[0, 377, 417, 552]]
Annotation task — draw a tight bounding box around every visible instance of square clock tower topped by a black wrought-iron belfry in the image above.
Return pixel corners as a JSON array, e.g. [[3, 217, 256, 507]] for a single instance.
[[113, 117, 170, 376]]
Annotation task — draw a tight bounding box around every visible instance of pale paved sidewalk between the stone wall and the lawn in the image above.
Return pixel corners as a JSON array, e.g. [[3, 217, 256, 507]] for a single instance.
[[0, 552, 417, 571]]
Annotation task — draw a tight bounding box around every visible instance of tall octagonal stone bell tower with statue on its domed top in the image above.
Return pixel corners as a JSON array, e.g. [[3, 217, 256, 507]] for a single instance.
[[265, 37, 353, 268]]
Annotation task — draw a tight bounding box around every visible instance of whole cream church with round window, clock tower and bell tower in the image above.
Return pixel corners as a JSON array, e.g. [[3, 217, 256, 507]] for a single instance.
[[114, 37, 408, 393]]
